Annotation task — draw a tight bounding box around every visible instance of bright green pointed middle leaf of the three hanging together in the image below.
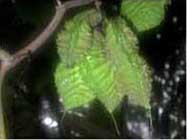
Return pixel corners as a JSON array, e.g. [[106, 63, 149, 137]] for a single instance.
[[82, 31, 122, 113]]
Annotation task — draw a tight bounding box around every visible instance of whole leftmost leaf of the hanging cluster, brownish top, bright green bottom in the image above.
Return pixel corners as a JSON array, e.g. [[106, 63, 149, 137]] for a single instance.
[[55, 10, 100, 110]]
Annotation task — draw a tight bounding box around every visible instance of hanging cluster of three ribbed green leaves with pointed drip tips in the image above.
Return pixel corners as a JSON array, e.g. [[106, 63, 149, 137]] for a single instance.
[[55, 9, 151, 113]]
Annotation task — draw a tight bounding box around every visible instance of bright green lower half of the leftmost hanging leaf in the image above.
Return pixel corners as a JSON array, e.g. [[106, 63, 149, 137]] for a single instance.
[[55, 63, 95, 110]]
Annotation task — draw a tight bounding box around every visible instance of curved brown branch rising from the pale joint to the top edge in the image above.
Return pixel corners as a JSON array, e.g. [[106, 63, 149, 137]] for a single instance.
[[7, 0, 95, 70]]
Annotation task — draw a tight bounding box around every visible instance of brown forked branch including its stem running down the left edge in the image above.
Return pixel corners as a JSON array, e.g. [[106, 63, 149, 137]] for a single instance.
[[0, 0, 95, 138]]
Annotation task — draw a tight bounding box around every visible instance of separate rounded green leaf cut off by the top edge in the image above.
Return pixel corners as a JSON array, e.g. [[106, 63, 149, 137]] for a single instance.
[[120, 0, 167, 32]]
